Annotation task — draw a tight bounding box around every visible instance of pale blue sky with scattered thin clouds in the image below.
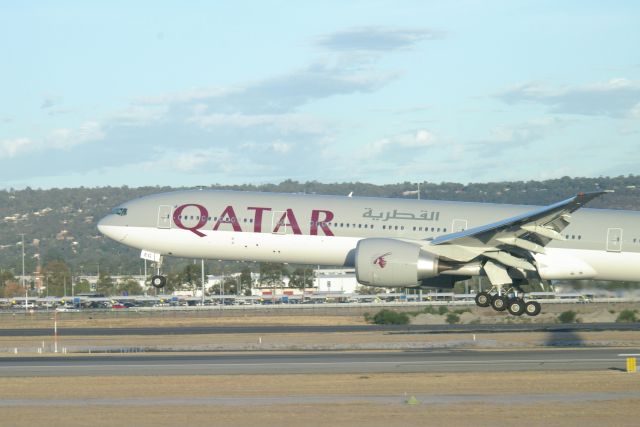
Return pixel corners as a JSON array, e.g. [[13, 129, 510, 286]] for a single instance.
[[0, 0, 640, 189]]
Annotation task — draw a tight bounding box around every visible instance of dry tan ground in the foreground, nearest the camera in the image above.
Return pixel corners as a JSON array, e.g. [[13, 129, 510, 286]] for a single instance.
[[0, 371, 640, 427]]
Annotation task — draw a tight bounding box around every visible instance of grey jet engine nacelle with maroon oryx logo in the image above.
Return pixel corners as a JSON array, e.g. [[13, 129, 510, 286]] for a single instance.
[[355, 238, 446, 288]]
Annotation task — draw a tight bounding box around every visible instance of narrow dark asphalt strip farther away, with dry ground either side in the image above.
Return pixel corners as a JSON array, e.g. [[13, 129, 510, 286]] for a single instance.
[[0, 323, 640, 337]]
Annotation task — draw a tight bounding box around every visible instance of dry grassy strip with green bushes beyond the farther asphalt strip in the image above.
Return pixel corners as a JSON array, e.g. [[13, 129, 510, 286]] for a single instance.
[[0, 303, 640, 328]]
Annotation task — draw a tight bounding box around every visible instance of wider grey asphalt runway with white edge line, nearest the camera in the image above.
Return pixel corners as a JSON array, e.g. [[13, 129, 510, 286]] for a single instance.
[[0, 348, 640, 377]]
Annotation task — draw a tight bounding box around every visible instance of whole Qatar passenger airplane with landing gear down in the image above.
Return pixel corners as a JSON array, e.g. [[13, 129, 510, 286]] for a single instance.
[[98, 190, 640, 316]]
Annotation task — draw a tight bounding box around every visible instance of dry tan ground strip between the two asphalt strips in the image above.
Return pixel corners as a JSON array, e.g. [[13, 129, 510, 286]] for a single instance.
[[0, 331, 640, 358]]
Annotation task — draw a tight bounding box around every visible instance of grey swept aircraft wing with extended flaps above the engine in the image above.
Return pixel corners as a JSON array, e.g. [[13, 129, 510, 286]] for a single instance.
[[430, 191, 607, 269]]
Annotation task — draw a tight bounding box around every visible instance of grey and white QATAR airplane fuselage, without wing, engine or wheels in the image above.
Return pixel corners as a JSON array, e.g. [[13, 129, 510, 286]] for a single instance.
[[99, 191, 640, 281]]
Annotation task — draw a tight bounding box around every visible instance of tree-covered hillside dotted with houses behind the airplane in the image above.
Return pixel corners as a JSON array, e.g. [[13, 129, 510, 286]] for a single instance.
[[0, 176, 640, 274]]
